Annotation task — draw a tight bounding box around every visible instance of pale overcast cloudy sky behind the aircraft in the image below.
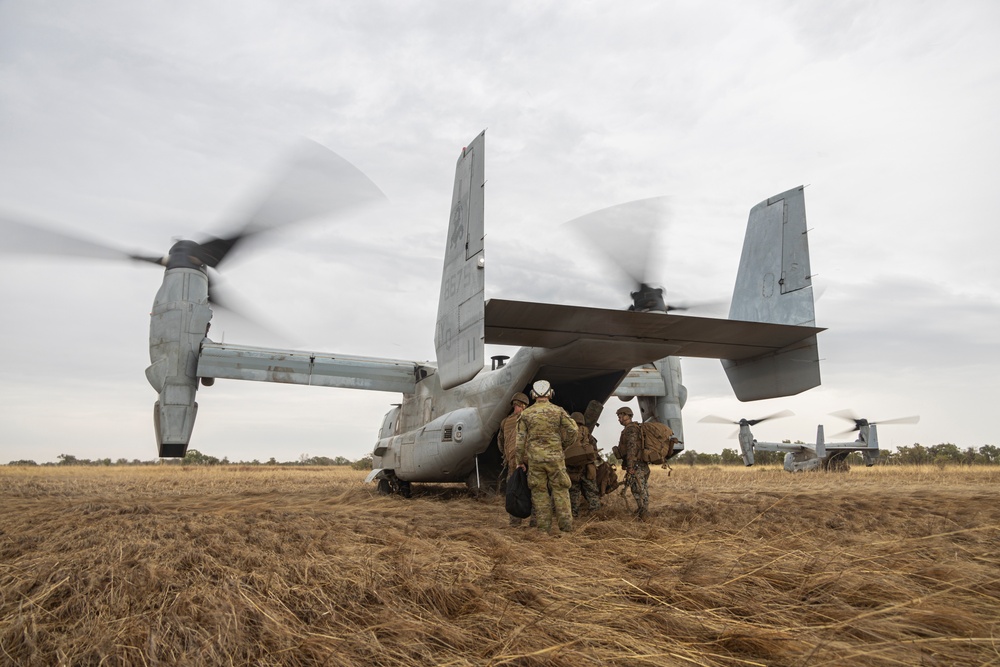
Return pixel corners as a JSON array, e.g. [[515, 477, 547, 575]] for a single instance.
[[0, 0, 1000, 463]]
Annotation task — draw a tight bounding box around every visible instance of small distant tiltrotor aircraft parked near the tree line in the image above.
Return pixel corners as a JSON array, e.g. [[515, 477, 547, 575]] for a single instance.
[[700, 410, 920, 472]]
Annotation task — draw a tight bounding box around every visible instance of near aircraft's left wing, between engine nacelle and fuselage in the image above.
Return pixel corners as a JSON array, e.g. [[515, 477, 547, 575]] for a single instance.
[[197, 341, 431, 394]]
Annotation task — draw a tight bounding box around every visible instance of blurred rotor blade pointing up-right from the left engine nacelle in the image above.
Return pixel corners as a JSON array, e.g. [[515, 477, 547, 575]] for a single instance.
[[207, 139, 387, 267]]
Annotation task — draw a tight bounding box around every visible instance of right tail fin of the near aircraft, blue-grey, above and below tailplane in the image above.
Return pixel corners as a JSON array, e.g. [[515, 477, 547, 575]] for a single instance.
[[722, 186, 820, 401]]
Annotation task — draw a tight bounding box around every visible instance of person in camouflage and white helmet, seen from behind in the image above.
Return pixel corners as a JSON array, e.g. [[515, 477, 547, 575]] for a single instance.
[[517, 380, 577, 533]]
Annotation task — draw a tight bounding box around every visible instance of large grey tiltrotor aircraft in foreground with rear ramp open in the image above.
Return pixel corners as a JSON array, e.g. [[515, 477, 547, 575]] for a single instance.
[[1, 132, 823, 493]]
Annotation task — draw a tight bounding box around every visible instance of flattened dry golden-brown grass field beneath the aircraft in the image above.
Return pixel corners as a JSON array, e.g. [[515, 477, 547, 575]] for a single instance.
[[0, 466, 1000, 667]]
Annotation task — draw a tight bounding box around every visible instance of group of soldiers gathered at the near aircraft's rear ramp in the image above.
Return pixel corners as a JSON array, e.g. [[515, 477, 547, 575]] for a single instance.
[[497, 380, 649, 533]]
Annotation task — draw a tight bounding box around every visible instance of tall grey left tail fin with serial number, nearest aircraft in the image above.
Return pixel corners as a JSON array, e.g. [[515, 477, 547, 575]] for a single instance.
[[434, 130, 486, 389]]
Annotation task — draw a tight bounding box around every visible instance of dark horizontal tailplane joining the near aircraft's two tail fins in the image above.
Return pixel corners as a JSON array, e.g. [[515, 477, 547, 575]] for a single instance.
[[485, 299, 823, 361]]
